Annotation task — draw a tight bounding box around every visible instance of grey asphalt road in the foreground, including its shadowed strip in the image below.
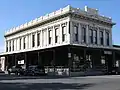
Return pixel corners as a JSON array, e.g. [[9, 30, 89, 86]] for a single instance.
[[0, 75, 120, 90]]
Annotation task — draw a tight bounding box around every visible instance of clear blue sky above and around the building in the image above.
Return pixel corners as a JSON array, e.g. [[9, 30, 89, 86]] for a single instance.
[[0, 0, 120, 52]]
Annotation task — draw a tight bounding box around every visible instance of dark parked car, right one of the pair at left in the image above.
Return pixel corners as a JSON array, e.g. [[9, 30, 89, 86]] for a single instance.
[[24, 65, 46, 76]]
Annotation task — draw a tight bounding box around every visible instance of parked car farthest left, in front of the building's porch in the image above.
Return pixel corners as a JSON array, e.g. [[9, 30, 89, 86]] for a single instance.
[[8, 66, 24, 75]]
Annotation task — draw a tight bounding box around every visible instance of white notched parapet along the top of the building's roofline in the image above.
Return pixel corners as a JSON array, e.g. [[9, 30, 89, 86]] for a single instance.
[[5, 5, 115, 36]]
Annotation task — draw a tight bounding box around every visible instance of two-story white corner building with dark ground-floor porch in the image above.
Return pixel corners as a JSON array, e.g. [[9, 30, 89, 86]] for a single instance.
[[1, 5, 115, 74]]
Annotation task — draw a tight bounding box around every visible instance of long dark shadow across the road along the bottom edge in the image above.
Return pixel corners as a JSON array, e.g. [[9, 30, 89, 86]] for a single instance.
[[0, 83, 95, 90]]
